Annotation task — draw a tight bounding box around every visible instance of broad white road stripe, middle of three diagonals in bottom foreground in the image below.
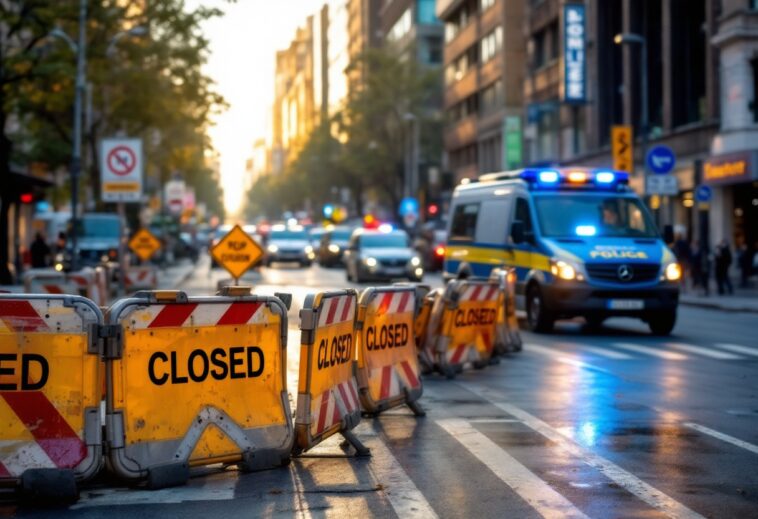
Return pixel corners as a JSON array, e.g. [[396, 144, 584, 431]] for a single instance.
[[436, 418, 587, 518]]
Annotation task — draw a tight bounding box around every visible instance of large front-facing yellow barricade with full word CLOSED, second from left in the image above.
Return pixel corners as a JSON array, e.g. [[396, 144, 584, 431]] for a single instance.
[[105, 287, 294, 488]]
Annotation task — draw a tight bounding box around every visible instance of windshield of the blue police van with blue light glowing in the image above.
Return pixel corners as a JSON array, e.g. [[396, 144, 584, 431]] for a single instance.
[[535, 194, 658, 238]]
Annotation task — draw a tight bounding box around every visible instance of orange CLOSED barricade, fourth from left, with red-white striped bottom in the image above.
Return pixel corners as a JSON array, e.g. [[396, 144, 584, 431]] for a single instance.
[[357, 287, 425, 416]]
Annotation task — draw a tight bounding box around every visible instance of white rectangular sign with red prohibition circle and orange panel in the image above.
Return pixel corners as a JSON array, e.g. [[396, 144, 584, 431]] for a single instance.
[[100, 139, 142, 202]]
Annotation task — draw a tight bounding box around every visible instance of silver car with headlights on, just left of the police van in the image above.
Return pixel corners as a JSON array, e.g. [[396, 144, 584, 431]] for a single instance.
[[345, 229, 424, 283]]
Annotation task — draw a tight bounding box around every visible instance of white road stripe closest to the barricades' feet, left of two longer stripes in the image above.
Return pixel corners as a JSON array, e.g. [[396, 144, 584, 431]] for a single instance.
[[361, 435, 437, 518]]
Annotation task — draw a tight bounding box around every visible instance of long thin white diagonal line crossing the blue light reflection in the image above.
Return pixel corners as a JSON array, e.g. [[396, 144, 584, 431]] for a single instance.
[[457, 382, 703, 519]]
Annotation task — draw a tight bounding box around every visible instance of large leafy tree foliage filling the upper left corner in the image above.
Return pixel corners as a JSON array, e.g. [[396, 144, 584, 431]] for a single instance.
[[0, 0, 224, 283]]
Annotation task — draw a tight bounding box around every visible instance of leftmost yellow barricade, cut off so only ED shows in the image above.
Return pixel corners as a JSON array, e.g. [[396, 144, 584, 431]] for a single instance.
[[0, 294, 103, 500]]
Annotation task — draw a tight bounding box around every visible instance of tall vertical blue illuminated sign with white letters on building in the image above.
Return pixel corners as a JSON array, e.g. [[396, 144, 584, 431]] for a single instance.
[[563, 4, 587, 103]]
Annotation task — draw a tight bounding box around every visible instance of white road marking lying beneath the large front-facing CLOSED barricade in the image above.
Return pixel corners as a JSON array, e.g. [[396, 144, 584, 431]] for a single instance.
[[70, 472, 239, 510]]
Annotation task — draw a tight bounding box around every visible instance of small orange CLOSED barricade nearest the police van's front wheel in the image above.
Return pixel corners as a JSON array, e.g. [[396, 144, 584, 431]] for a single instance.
[[430, 279, 500, 378]]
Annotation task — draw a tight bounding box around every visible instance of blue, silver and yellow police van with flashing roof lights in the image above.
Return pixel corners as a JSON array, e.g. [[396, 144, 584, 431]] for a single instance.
[[444, 168, 682, 335]]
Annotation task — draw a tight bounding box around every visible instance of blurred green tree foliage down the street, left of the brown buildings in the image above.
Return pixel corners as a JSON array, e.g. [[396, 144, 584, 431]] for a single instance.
[[248, 49, 442, 216]]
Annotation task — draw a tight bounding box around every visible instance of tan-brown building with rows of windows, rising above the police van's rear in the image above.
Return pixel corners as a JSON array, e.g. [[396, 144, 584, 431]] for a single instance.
[[437, 0, 526, 183]]
